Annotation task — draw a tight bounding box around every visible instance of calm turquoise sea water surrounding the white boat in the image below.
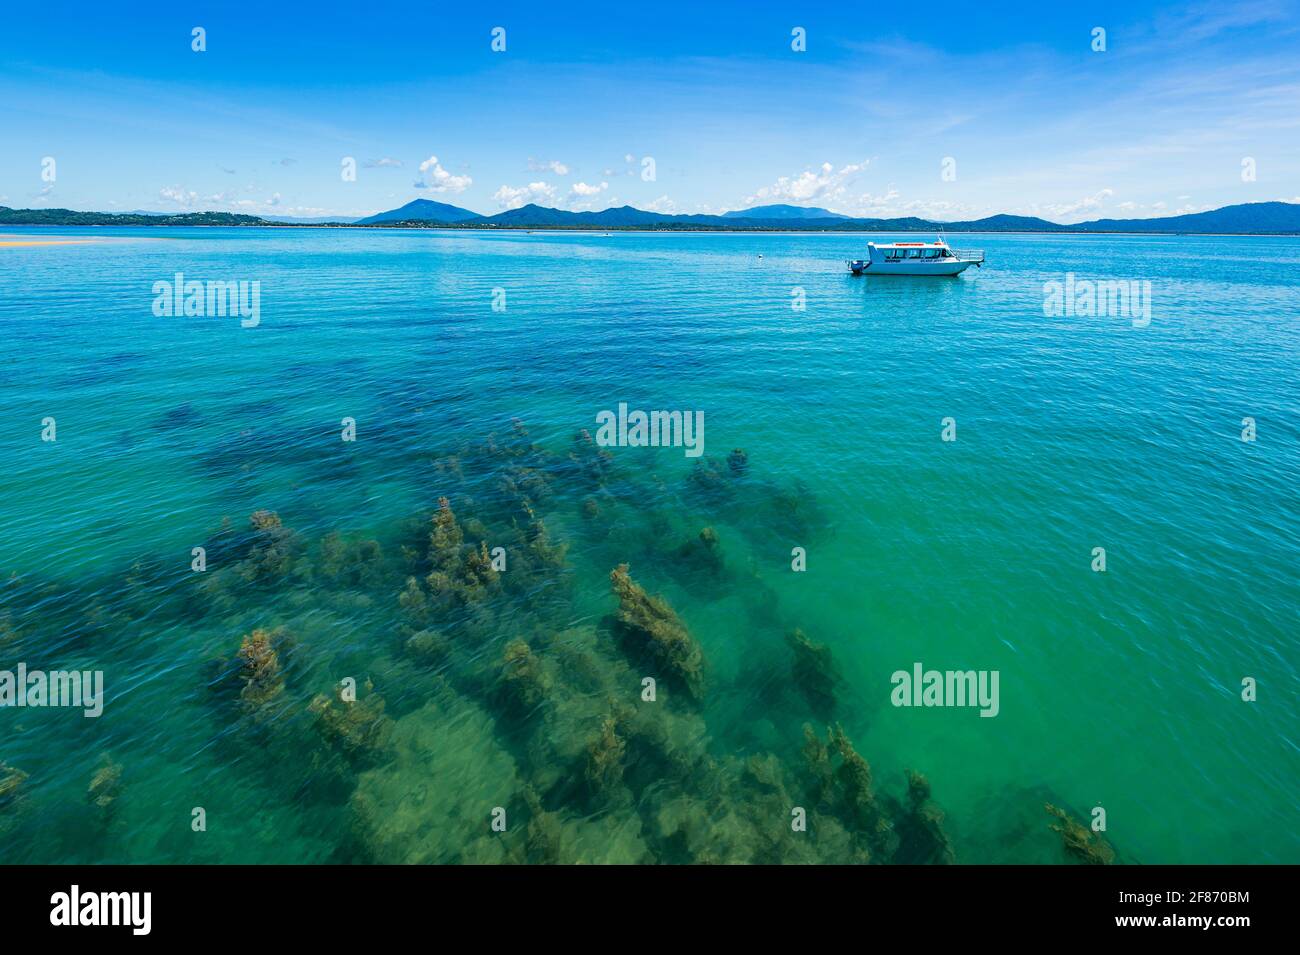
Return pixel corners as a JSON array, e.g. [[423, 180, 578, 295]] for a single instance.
[[0, 229, 1300, 863]]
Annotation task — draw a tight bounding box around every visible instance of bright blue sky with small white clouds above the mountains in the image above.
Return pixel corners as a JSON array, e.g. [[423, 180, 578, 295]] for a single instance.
[[0, 0, 1300, 222]]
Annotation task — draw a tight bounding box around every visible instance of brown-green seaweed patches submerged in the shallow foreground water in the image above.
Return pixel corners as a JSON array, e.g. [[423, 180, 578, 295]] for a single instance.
[[0, 418, 1113, 864]]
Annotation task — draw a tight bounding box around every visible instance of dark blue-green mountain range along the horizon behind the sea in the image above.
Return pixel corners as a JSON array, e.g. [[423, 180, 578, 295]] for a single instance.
[[0, 199, 1300, 235]]
